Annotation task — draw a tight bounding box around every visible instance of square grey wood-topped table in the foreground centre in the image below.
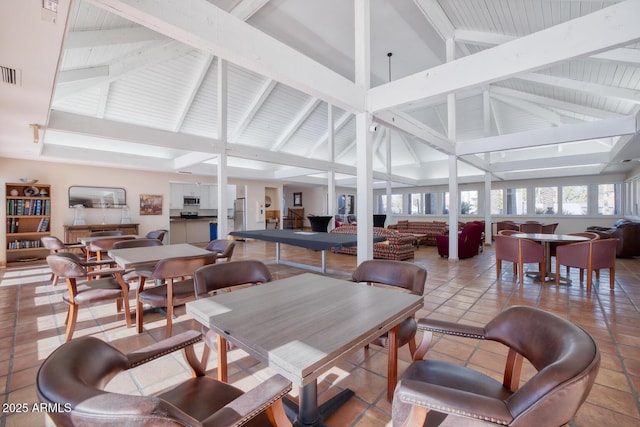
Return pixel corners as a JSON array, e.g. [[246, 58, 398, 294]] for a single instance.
[[187, 273, 424, 426]]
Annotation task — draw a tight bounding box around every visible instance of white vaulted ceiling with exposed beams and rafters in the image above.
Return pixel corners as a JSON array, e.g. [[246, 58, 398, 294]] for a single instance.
[[0, 0, 640, 186]]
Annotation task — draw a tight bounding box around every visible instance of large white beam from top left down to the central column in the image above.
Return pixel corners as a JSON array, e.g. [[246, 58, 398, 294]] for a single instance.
[[91, 0, 366, 111]]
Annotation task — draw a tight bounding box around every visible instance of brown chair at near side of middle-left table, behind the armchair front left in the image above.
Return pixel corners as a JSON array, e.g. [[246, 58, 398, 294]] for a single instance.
[[136, 253, 216, 338]]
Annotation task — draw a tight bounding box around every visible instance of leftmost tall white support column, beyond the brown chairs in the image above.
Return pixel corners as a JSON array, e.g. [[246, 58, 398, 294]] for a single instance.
[[216, 57, 230, 239]]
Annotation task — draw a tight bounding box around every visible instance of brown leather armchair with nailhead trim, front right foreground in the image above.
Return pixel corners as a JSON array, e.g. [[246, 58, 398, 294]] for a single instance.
[[392, 306, 600, 426]]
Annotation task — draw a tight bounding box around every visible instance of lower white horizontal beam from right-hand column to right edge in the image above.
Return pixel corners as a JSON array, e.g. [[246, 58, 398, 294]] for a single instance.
[[456, 116, 637, 156]]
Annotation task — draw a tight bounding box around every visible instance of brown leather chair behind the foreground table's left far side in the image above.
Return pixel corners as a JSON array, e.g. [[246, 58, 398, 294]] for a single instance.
[[193, 260, 273, 372]]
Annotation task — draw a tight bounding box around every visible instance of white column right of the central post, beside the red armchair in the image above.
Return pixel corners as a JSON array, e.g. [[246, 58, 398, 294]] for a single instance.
[[446, 39, 460, 261]]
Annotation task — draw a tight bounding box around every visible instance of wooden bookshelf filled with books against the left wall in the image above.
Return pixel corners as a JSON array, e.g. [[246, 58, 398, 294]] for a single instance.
[[5, 183, 51, 266]]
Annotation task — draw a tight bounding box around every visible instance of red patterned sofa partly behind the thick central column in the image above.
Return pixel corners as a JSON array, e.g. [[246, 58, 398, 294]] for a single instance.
[[331, 225, 415, 261]]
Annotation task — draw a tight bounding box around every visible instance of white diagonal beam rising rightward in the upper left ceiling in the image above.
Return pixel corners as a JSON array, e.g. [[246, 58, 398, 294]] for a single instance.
[[55, 40, 193, 100]]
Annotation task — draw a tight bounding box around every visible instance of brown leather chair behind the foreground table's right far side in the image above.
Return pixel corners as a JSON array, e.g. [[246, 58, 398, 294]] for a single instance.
[[351, 259, 427, 356]]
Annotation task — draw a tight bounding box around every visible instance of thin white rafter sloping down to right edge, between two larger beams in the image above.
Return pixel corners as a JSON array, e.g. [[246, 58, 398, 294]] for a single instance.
[[515, 72, 640, 104]]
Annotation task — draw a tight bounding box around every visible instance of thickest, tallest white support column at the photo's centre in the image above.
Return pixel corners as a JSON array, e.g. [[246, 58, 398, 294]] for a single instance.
[[354, 0, 373, 265]]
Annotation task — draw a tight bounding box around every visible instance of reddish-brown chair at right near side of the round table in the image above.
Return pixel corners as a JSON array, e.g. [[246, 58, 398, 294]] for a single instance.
[[556, 239, 618, 292]]
